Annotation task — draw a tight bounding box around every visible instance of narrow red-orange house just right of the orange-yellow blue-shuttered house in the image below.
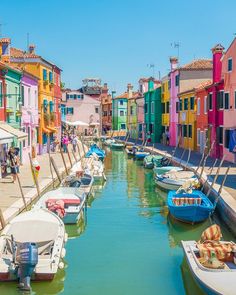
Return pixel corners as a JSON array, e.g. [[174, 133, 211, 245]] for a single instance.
[[53, 65, 62, 140]]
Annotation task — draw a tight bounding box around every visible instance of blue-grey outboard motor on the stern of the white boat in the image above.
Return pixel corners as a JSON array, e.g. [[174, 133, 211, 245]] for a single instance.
[[16, 243, 38, 291]]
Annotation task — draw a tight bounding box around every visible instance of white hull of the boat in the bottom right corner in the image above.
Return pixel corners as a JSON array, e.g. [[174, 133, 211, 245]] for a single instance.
[[181, 241, 236, 295]]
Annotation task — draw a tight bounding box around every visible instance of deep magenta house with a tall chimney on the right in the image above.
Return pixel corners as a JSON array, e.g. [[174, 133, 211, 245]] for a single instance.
[[206, 44, 224, 158]]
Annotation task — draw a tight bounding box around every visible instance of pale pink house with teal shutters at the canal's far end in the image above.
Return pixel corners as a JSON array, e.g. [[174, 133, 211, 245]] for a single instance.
[[62, 90, 101, 134]]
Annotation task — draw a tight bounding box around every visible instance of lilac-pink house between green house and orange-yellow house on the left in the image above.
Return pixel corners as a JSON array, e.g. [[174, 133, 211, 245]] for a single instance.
[[21, 71, 39, 163]]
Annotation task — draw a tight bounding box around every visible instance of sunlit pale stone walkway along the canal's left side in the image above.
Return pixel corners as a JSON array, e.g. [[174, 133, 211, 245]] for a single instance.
[[0, 142, 86, 228]]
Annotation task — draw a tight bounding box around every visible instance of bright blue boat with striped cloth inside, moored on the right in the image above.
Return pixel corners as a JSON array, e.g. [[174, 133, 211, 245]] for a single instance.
[[167, 190, 214, 223]]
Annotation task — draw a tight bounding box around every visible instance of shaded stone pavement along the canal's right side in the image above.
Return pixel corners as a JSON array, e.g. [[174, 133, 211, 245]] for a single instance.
[[120, 138, 236, 200]]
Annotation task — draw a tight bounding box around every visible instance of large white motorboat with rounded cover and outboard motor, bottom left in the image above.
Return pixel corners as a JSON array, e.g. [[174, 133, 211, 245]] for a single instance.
[[0, 208, 67, 290]]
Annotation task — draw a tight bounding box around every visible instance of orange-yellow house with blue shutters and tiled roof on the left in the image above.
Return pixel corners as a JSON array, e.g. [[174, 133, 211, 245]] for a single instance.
[[10, 45, 57, 154]]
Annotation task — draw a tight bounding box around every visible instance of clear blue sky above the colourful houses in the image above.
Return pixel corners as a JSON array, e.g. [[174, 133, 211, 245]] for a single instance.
[[0, 0, 236, 92]]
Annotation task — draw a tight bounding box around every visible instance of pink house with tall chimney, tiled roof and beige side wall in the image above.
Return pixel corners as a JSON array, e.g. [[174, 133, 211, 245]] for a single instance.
[[169, 57, 212, 146]]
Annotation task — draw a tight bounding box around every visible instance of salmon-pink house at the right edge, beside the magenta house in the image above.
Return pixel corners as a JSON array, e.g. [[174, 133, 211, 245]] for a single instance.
[[222, 38, 236, 163]]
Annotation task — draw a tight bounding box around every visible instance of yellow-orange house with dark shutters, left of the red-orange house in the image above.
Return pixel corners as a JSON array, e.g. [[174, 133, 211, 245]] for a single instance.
[[178, 89, 197, 150]]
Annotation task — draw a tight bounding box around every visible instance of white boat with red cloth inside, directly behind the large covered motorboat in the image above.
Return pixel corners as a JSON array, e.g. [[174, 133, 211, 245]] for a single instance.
[[35, 187, 86, 224]]
